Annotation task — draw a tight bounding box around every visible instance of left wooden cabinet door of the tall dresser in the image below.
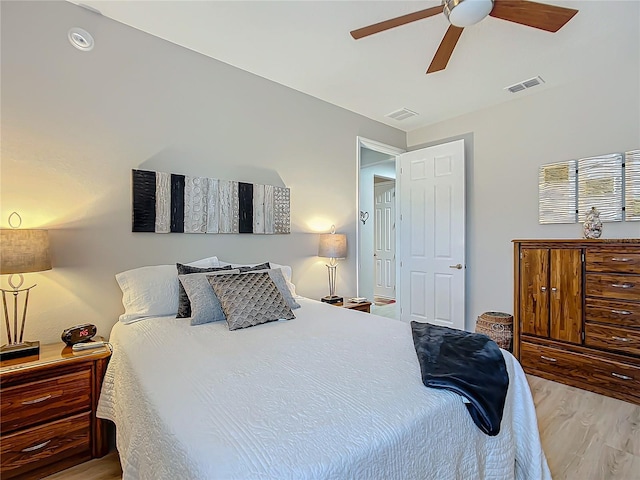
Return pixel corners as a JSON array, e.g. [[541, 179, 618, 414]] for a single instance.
[[520, 248, 549, 337]]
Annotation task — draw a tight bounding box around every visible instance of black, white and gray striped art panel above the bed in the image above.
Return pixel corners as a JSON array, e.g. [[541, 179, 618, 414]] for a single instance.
[[131, 169, 291, 235]]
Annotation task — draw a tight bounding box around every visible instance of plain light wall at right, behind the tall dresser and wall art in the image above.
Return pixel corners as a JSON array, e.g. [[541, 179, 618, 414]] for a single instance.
[[407, 28, 640, 329]]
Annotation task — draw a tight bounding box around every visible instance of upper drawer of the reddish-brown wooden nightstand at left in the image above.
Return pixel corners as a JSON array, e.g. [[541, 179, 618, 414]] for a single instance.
[[0, 366, 91, 436]]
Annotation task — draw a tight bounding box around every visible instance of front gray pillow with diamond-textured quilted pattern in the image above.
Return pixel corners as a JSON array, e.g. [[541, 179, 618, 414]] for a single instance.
[[207, 272, 296, 330]]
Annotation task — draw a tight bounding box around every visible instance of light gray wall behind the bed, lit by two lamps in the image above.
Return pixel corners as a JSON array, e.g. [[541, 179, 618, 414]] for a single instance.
[[0, 1, 405, 343]]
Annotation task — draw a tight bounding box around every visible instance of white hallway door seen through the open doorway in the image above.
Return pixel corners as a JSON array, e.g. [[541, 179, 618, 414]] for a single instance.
[[373, 181, 396, 299]]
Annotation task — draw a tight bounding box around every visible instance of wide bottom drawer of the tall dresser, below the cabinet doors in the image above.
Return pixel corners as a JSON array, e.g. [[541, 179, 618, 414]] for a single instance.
[[520, 342, 640, 402]]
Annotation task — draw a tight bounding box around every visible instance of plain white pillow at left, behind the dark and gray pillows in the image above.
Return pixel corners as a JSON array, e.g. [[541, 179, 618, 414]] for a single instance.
[[116, 257, 220, 323]]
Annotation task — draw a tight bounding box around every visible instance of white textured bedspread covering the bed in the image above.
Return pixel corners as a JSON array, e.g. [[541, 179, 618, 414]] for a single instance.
[[98, 299, 551, 480]]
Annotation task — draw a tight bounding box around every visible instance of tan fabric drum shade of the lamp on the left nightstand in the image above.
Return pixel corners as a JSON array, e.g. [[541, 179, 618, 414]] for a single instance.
[[0, 228, 51, 275]]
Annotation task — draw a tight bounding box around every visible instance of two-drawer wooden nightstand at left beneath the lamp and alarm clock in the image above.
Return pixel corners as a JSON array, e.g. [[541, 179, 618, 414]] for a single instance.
[[0, 343, 111, 480]]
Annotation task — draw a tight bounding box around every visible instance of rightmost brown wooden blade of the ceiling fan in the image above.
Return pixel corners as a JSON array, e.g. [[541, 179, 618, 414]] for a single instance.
[[489, 0, 578, 32]]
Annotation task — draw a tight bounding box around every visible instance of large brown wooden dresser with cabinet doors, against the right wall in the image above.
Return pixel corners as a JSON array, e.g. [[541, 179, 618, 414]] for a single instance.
[[513, 239, 640, 404]]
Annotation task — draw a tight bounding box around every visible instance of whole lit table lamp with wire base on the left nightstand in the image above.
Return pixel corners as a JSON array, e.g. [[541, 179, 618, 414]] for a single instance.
[[0, 212, 51, 360]]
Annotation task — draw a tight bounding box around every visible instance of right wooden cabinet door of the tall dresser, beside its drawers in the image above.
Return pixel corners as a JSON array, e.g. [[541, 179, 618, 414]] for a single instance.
[[549, 249, 582, 344]]
